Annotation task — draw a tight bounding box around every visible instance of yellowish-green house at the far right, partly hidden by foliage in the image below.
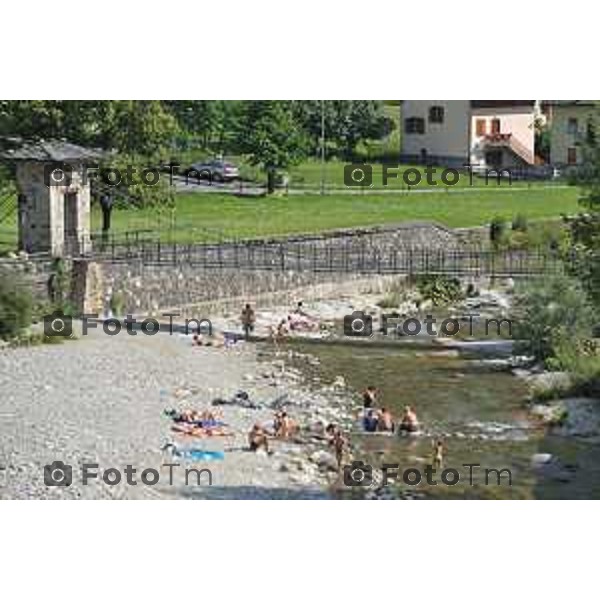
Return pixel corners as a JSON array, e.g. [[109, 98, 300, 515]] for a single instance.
[[544, 100, 600, 167]]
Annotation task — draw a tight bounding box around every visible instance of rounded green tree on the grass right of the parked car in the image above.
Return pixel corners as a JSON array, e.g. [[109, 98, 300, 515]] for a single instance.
[[238, 100, 306, 194]]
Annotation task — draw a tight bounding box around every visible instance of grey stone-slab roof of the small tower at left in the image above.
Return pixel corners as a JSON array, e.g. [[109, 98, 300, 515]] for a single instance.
[[0, 137, 104, 162]]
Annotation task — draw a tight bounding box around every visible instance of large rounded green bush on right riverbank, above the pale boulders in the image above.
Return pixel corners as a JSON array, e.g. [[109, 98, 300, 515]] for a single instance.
[[512, 276, 594, 368]]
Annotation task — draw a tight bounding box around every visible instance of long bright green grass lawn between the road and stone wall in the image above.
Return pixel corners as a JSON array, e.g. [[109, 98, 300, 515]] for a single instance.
[[93, 188, 578, 243]]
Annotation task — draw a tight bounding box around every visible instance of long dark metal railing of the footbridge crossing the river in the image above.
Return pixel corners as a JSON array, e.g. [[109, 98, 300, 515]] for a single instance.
[[90, 240, 563, 277]]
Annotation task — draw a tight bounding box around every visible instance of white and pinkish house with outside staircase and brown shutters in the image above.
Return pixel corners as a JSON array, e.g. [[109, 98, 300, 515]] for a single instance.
[[402, 100, 541, 168]]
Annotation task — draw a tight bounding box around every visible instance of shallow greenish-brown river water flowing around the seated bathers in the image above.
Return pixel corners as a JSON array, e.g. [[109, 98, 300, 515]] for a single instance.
[[288, 345, 600, 498]]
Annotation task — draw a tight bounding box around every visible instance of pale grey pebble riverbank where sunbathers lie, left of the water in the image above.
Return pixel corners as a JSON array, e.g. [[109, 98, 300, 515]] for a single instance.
[[0, 322, 360, 499]]
